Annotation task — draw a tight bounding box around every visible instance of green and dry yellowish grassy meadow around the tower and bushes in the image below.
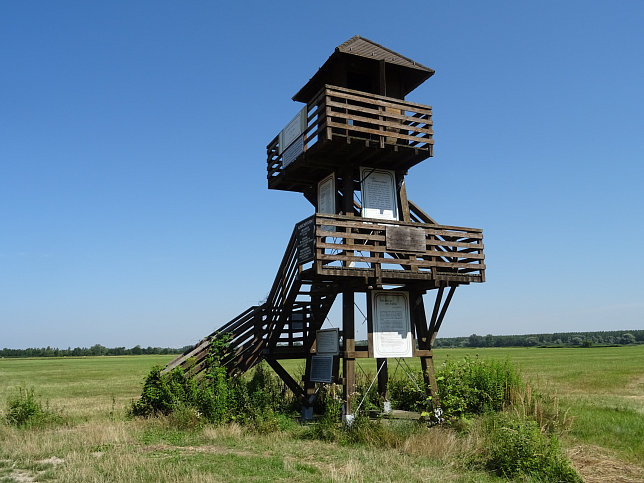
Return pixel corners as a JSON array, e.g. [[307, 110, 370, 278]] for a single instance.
[[0, 346, 644, 482]]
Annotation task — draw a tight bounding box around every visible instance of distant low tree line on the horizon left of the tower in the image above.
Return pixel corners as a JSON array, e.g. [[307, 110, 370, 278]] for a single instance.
[[0, 344, 192, 357]]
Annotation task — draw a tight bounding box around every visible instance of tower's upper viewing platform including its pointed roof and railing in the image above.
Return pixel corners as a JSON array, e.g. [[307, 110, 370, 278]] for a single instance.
[[267, 36, 434, 192]]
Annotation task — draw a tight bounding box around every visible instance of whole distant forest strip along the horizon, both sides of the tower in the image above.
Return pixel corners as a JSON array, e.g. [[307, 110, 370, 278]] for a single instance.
[[0, 330, 644, 358]]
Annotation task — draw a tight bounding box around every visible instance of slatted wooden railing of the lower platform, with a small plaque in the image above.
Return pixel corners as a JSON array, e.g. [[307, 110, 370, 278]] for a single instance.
[[312, 213, 485, 283]]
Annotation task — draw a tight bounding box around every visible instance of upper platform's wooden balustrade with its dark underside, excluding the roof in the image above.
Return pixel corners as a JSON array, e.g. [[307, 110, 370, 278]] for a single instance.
[[266, 85, 434, 191]]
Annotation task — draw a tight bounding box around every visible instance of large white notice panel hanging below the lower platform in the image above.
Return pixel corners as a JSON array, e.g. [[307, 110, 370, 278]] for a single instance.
[[371, 290, 413, 358]]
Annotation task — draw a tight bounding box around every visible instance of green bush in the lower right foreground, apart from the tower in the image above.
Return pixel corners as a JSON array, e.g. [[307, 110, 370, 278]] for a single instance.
[[473, 413, 582, 482]]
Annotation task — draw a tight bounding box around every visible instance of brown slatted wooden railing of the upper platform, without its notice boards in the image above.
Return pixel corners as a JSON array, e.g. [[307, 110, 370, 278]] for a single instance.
[[266, 85, 434, 183]]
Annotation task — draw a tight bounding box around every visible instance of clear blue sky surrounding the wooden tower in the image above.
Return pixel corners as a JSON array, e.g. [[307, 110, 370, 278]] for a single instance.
[[0, 0, 644, 348]]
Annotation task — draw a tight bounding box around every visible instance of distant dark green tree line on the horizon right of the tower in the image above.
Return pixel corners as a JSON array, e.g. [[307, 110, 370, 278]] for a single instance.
[[434, 330, 644, 347]]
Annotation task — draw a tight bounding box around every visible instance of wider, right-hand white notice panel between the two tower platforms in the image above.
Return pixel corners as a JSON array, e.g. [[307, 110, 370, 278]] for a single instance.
[[360, 167, 398, 220]]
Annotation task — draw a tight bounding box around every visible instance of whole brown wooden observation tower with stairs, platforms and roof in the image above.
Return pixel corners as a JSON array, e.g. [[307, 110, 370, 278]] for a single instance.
[[166, 36, 485, 413]]
